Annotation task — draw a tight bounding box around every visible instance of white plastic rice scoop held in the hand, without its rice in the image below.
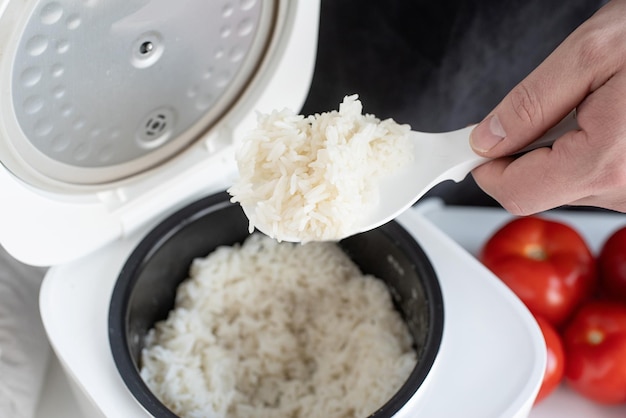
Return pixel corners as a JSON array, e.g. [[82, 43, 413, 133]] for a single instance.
[[243, 112, 579, 242]]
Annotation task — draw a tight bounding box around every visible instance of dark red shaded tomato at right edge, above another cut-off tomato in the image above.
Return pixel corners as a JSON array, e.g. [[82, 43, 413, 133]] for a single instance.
[[598, 227, 626, 302]]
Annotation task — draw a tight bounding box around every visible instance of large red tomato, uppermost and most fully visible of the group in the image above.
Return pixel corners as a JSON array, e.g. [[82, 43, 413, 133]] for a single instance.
[[479, 216, 596, 327]]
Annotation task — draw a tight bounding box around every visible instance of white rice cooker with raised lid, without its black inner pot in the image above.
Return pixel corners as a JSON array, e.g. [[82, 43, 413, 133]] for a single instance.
[[0, 0, 545, 418]]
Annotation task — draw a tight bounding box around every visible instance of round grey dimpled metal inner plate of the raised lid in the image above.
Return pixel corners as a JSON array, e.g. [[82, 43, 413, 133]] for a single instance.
[[0, 0, 274, 185]]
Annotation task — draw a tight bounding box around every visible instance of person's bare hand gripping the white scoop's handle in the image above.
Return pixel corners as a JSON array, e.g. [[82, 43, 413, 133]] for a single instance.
[[470, 0, 626, 216]]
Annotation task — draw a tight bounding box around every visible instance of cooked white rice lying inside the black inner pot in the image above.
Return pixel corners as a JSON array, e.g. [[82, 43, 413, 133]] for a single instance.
[[141, 234, 417, 418]]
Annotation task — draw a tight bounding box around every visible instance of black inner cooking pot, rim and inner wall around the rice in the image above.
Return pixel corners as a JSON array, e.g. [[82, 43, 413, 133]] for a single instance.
[[109, 192, 443, 418]]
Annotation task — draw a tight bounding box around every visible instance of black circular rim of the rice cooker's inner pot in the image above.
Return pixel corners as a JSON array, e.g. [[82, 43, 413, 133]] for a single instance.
[[108, 191, 444, 418]]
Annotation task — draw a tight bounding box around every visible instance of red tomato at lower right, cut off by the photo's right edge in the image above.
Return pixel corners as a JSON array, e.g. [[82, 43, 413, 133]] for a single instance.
[[563, 301, 626, 404]]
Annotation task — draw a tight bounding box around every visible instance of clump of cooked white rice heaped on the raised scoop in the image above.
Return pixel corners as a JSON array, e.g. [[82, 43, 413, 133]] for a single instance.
[[228, 95, 413, 242]]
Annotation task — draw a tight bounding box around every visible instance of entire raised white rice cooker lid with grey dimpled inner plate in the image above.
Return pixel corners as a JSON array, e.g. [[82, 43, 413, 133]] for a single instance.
[[0, 0, 319, 265]]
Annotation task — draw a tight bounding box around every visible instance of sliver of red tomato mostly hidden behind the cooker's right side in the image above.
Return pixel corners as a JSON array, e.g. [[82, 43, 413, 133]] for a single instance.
[[535, 316, 565, 405]]
